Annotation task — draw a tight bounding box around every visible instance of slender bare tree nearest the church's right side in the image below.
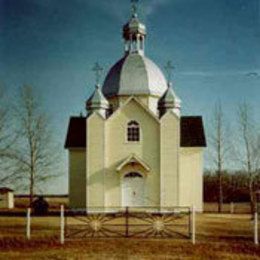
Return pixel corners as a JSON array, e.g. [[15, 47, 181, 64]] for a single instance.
[[210, 102, 229, 212]]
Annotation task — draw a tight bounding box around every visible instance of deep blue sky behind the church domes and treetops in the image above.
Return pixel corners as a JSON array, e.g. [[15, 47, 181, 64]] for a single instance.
[[0, 0, 260, 192]]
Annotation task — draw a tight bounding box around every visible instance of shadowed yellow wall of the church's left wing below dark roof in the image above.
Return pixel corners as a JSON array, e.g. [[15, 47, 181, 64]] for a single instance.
[[69, 149, 87, 208]]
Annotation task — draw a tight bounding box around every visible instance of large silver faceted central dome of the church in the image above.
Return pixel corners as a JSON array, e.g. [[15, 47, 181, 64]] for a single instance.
[[103, 53, 167, 97]]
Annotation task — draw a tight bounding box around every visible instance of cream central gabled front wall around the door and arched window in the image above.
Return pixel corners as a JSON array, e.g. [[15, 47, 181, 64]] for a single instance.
[[105, 99, 160, 207]]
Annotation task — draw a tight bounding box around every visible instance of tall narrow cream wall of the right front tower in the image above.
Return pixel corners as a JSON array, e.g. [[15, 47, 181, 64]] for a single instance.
[[160, 112, 180, 207]]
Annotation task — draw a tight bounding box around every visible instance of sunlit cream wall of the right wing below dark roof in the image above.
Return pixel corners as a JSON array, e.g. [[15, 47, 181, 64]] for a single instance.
[[179, 148, 203, 211]]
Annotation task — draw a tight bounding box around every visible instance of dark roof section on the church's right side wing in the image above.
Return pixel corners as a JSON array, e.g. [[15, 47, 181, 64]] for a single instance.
[[181, 116, 207, 147]]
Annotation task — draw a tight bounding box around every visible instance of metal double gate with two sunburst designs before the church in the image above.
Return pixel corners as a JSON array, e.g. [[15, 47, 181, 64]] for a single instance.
[[65, 207, 191, 240]]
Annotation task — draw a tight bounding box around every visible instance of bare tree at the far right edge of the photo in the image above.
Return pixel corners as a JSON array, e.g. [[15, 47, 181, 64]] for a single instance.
[[236, 102, 260, 213]]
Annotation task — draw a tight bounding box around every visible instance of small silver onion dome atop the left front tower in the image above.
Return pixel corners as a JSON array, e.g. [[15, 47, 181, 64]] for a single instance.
[[86, 85, 109, 115]]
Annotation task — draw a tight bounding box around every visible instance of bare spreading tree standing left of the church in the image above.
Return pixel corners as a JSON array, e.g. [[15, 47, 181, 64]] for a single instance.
[[10, 86, 57, 205]]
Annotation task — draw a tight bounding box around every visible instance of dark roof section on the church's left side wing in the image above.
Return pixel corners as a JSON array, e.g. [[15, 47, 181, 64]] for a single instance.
[[65, 117, 87, 149]]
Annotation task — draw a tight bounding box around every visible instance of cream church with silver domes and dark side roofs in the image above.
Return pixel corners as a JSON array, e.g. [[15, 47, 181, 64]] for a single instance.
[[65, 4, 206, 212]]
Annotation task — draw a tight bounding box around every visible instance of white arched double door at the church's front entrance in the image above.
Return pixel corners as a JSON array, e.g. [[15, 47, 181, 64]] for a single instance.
[[122, 172, 144, 207]]
